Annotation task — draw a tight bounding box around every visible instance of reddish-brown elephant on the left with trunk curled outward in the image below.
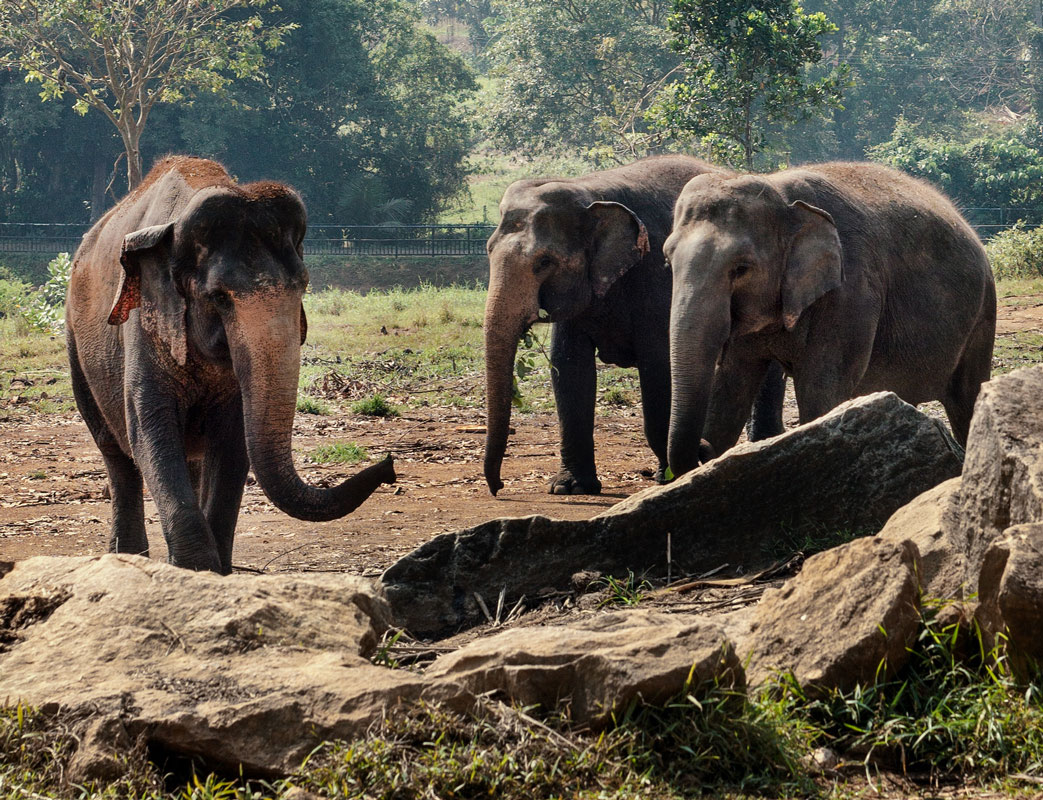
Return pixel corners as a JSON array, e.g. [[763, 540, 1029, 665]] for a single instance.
[[66, 156, 395, 575]]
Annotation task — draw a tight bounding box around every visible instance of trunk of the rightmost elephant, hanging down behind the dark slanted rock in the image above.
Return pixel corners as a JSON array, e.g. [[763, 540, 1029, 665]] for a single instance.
[[666, 285, 731, 477]]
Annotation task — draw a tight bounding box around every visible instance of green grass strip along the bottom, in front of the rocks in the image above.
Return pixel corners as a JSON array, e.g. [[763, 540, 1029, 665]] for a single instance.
[[6, 603, 1043, 800]]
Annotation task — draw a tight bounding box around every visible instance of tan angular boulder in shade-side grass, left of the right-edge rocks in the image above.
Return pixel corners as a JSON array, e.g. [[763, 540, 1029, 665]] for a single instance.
[[736, 536, 920, 695]]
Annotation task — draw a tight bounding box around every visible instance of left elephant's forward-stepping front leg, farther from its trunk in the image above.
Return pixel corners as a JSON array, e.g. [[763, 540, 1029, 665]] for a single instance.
[[127, 392, 221, 572]]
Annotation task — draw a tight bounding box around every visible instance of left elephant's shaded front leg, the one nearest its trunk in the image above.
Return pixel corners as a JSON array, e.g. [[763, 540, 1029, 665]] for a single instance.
[[199, 398, 249, 575]]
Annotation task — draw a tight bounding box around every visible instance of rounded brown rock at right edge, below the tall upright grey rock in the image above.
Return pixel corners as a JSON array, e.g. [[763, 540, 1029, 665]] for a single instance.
[[975, 524, 1043, 678]]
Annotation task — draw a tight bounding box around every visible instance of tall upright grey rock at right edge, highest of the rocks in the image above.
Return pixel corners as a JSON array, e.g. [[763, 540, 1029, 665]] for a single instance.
[[954, 366, 1043, 592]]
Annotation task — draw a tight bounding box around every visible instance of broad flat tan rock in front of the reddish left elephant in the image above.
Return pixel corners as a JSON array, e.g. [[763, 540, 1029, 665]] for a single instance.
[[0, 556, 466, 779]]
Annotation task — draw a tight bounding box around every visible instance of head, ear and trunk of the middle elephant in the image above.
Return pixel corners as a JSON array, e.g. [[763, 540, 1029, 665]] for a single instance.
[[485, 180, 649, 494]]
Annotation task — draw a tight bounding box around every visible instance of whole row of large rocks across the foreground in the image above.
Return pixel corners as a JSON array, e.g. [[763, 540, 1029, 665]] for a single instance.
[[6, 367, 1043, 780]]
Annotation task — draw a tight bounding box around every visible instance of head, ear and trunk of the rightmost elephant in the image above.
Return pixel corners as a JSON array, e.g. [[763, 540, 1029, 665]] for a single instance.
[[663, 175, 844, 476]]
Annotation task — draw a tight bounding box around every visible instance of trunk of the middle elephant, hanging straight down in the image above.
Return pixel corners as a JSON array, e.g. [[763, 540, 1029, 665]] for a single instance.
[[484, 272, 539, 494]]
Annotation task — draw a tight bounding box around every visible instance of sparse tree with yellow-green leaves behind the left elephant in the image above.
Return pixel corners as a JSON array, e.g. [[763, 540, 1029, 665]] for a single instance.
[[0, 0, 292, 189]]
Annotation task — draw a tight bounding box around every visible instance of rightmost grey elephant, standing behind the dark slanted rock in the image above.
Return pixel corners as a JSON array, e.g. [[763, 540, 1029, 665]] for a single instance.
[[664, 163, 996, 475]]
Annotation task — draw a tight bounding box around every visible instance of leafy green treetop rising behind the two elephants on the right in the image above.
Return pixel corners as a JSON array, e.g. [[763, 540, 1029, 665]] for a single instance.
[[649, 0, 847, 169]]
